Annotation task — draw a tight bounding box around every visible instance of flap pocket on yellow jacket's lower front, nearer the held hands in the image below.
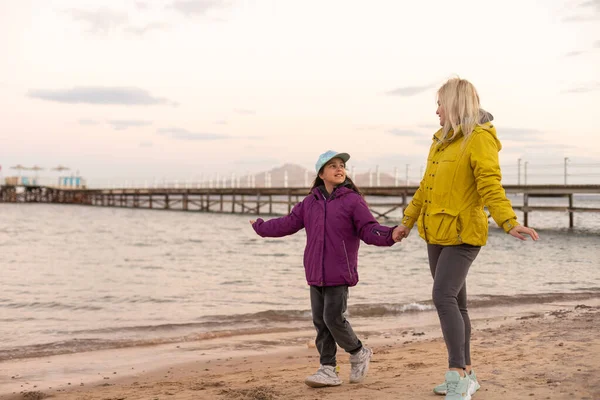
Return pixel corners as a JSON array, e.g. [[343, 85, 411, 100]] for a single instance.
[[423, 207, 462, 245]]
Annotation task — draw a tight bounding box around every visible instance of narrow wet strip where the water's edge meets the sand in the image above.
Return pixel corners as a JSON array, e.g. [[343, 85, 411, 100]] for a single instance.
[[0, 288, 600, 367]]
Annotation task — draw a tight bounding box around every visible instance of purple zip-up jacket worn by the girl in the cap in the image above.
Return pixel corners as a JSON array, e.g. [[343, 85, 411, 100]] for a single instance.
[[253, 186, 394, 286]]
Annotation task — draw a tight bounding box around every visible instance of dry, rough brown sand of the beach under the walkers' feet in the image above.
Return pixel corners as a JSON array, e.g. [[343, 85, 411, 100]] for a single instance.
[[3, 299, 600, 400]]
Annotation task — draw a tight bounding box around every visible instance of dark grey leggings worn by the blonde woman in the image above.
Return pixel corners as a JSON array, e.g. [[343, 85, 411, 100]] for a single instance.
[[427, 244, 481, 368]]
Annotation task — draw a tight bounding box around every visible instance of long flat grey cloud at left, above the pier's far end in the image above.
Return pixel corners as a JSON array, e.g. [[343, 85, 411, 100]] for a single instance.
[[28, 86, 177, 105]]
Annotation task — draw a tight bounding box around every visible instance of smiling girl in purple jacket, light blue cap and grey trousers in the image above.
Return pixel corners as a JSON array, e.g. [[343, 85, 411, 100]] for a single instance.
[[250, 150, 400, 387]]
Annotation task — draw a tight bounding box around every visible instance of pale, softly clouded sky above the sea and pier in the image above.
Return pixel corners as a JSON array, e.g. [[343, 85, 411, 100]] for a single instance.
[[0, 0, 600, 186]]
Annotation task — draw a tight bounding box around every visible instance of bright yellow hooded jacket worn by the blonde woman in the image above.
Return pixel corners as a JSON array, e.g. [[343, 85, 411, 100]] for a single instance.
[[402, 122, 518, 246]]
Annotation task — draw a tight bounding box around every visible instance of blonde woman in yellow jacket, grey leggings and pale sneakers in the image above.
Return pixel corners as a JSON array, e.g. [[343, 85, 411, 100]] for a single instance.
[[394, 78, 538, 400]]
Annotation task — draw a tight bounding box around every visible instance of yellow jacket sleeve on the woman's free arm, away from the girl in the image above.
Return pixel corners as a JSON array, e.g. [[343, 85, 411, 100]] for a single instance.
[[471, 132, 519, 232]]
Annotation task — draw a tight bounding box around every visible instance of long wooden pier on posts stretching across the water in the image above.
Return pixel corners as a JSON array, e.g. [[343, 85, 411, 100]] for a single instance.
[[0, 185, 600, 227]]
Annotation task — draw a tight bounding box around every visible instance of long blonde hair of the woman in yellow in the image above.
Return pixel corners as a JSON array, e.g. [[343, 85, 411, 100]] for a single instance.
[[437, 78, 479, 142]]
